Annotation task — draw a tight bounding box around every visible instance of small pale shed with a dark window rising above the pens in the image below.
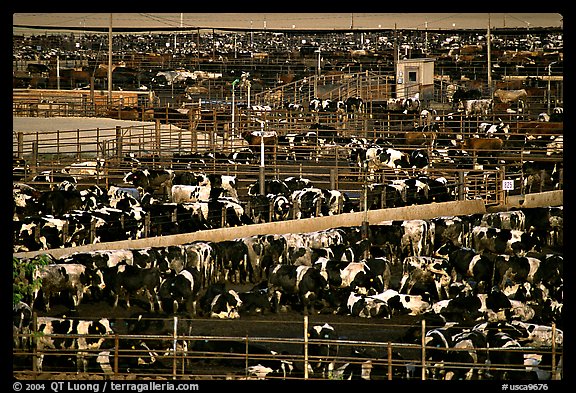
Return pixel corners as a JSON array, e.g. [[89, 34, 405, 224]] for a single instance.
[[396, 58, 435, 101]]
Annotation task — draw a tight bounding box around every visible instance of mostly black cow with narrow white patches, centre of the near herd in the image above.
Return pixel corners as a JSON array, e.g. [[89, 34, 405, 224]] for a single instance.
[[268, 264, 329, 315]]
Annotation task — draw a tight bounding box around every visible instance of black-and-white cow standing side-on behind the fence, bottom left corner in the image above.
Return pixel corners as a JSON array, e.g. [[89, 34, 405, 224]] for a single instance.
[[36, 317, 113, 372]]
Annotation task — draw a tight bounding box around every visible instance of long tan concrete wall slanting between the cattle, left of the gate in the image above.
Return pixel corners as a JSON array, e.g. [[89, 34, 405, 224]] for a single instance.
[[13, 199, 486, 258]]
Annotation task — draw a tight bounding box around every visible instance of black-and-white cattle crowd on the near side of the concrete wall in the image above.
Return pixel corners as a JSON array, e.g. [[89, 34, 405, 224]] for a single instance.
[[15, 198, 563, 379]]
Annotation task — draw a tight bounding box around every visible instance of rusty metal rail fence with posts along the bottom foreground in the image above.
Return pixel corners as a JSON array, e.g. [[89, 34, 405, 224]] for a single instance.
[[13, 316, 563, 380]]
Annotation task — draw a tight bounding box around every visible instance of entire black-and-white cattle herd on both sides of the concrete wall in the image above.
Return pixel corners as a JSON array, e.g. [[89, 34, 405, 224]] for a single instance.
[[12, 23, 564, 380]]
